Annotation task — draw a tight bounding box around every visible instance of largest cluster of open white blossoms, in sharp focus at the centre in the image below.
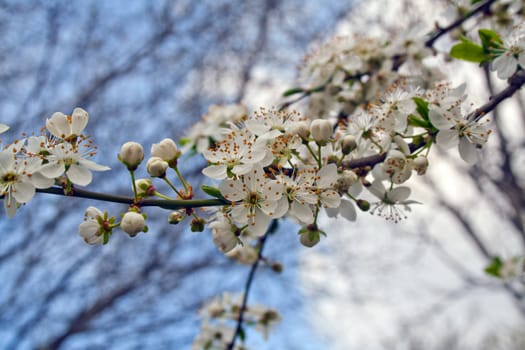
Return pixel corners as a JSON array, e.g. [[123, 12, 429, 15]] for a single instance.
[[193, 76, 490, 253]]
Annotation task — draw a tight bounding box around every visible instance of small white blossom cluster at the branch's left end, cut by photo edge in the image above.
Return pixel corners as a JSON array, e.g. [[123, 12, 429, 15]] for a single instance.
[[0, 108, 109, 217]]
